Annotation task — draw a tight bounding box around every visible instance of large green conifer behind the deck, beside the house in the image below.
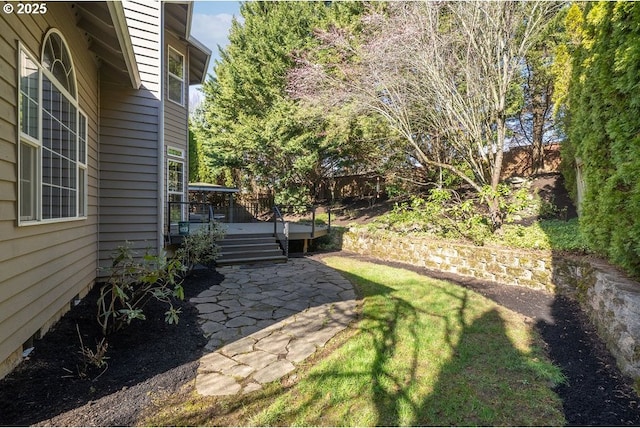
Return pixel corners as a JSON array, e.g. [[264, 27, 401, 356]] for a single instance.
[[192, 2, 370, 204]]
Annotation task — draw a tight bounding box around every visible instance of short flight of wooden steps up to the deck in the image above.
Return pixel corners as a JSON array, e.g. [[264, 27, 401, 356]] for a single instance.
[[216, 233, 287, 266]]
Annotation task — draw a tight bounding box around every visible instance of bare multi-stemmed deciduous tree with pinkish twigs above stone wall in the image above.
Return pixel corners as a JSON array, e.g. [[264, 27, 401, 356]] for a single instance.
[[289, 1, 559, 228]]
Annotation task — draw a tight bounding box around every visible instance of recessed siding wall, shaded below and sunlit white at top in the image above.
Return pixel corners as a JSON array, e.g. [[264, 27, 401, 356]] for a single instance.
[[99, 0, 164, 266]]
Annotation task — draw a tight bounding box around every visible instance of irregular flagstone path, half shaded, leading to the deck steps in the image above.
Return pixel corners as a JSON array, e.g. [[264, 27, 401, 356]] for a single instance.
[[191, 258, 356, 396]]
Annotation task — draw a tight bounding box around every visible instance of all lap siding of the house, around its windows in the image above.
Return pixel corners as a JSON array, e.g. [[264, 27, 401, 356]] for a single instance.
[[0, 0, 206, 378]]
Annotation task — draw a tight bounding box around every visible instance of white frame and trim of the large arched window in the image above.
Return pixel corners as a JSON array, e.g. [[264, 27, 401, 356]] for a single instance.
[[16, 34, 89, 226]]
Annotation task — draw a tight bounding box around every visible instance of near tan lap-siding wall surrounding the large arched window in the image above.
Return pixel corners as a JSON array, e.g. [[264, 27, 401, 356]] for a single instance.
[[0, 2, 99, 377]]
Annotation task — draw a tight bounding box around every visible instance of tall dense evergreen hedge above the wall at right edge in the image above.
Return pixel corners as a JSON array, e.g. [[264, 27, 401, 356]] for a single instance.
[[563, 2, 640, 275]]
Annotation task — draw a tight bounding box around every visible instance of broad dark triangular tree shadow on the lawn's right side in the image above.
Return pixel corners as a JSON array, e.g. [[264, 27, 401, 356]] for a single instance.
[[414, 309, 563, 426]]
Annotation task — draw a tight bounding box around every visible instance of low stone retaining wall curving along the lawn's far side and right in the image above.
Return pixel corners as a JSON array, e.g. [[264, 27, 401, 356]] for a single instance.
[[342, 229, 640, 382]]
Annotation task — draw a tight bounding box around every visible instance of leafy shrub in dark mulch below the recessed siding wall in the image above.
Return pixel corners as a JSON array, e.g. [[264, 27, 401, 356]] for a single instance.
[[97, 243, 185, 335]]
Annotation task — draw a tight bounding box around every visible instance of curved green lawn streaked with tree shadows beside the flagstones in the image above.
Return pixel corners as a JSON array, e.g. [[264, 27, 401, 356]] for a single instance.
[[142, 257, 565, 426]]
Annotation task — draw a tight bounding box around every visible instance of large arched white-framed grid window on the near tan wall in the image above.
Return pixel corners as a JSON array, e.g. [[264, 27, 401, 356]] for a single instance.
[[18, 30, 87, 225]]
